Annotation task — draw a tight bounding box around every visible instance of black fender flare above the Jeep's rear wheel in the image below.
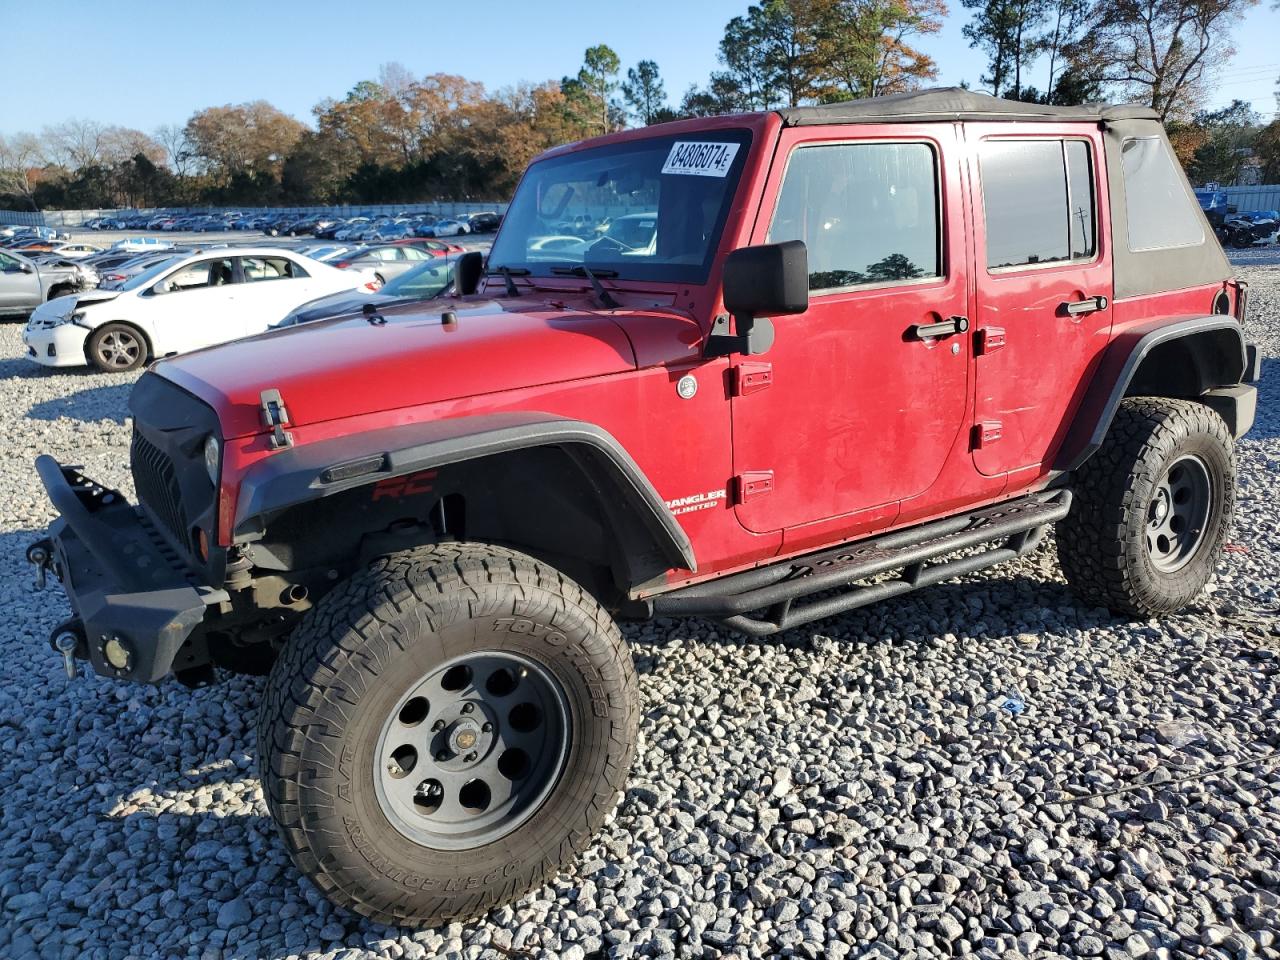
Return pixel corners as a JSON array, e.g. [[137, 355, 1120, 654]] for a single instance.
[[1053, 314, 1248, 471]]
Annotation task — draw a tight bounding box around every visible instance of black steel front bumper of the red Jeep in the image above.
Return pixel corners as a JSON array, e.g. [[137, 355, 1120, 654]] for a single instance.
[[28, 456, 216, 684]]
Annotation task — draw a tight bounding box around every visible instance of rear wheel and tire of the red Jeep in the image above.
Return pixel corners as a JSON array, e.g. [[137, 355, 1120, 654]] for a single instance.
[[1057, 397, 1235, 617]]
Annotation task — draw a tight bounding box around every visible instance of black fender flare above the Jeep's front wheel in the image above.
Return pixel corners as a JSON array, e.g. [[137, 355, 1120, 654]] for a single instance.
[[232, 412, 696, 570]]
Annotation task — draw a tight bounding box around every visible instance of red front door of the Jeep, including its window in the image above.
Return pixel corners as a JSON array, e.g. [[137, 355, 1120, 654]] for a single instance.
[[732, 124, 970, 543]]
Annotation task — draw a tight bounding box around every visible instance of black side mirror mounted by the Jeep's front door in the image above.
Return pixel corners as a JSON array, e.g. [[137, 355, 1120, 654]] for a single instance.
[[707, 241, 809, 357]]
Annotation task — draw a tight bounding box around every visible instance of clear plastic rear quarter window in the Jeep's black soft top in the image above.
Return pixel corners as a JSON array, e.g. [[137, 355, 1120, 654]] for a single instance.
[[1120, 137, 1204, 253]]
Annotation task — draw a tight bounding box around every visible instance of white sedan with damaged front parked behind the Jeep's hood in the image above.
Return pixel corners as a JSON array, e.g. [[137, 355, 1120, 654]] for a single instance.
[[22, 247, 375, 370]]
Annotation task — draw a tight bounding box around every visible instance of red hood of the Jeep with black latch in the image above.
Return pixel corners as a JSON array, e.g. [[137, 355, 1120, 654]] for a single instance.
[[156, 301, 650, 438]]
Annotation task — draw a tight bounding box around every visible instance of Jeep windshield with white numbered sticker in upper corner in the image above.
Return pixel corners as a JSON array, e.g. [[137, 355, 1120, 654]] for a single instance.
[[489, 131, 751, 283]]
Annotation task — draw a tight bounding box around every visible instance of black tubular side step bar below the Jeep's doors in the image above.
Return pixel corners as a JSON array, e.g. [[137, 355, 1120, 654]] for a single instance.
[[650, 490, 1071, 636]]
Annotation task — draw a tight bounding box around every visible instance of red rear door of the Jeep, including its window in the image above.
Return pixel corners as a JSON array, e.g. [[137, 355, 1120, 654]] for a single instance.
[[966, 124, 1112, 484]]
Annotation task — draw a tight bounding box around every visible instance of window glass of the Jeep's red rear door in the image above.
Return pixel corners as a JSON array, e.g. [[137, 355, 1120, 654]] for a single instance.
[[980, 140, 1097, 270]]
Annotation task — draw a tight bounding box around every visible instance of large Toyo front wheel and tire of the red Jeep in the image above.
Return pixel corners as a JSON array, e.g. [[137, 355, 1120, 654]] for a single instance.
[[259, 543, 637, 925]]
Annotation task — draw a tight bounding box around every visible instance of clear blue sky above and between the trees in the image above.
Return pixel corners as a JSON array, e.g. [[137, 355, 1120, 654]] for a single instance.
[[0, 0, 1280, 133]]
